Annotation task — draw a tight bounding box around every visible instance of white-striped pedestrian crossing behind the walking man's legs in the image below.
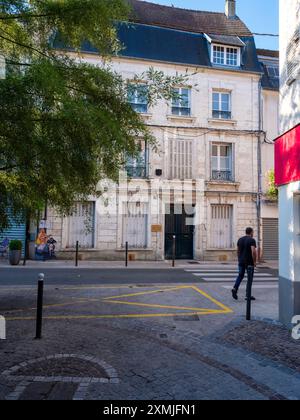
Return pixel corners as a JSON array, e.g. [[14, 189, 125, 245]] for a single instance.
[[185, 265, 278, 283]]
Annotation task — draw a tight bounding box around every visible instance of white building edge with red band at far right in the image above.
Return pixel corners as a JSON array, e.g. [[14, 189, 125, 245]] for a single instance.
[[275, 0, 300, 325]]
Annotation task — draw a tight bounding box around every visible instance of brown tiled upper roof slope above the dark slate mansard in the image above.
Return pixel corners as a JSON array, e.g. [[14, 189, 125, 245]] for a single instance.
[[127, 0, 252, 36]]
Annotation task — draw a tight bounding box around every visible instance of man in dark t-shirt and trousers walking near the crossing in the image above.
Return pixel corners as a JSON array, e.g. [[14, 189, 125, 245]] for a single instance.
[[232, 228, 257, 300]]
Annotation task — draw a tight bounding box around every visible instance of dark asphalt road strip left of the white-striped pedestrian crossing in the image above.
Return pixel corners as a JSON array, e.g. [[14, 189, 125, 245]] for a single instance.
[[0, 267, 202, 286]]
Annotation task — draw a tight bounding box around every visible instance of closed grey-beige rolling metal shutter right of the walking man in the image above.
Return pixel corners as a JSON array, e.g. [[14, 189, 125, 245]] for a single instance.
[[263, 219, 279, 260]]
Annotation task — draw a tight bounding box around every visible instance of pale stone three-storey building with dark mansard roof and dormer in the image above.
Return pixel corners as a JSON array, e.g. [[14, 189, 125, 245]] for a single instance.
[[48, 0, 278, 261]]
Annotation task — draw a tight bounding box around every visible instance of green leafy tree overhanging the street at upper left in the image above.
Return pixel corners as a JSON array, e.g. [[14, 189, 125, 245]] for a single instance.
[[0, 0, 186, 229]]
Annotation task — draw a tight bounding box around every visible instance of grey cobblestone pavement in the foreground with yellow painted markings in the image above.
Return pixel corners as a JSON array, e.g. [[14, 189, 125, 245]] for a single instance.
[[0, 276, 300, 400]]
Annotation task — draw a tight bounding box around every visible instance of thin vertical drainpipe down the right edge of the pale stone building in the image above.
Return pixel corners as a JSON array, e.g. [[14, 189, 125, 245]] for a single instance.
[[257, 77, 263, 262]]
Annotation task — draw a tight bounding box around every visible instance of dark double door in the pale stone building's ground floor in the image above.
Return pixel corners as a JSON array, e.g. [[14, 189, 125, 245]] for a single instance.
[[165, 204, 195, 260]]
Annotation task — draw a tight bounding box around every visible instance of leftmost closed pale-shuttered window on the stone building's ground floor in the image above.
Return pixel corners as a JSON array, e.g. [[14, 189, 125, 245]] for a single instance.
[[67, 202, 95, 249]]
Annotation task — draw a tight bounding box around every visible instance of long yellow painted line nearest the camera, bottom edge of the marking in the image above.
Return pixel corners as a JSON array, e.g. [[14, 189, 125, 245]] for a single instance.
[[6, 310, 228, 321]]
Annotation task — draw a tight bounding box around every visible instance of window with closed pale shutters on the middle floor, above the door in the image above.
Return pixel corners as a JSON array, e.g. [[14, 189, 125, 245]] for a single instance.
[[168, 139, 193, 180]]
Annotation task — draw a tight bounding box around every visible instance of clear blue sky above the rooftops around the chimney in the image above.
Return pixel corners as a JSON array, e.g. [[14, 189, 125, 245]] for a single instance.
[[147, 0, 279, 50]]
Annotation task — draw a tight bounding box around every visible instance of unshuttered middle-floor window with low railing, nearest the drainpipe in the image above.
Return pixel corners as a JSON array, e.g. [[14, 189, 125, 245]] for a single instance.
[[211, 144, 233, 181]]
